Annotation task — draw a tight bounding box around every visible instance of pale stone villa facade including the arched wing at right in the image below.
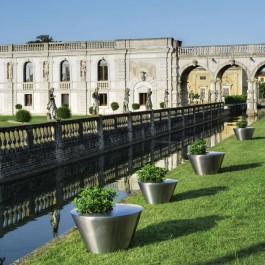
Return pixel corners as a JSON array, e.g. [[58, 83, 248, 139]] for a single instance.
[[0, 38, 265, 115]]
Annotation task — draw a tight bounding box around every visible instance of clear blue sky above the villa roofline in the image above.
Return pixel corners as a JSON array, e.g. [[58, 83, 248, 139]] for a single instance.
[[0, 0, 265, 46]]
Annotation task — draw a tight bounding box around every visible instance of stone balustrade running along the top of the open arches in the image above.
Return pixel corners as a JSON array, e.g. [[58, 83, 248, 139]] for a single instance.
[[178, 44, 265, 57]]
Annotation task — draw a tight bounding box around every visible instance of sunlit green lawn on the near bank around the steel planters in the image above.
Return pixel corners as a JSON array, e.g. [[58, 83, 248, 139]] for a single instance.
[[20, 118, 265, 265]]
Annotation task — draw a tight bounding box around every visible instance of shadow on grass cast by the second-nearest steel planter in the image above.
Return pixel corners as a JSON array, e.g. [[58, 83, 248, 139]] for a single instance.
[[171, 186, 228, 201]]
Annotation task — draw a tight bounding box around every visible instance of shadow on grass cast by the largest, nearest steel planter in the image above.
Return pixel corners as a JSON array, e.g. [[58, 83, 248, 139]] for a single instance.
[[132, 215, 224, 247]]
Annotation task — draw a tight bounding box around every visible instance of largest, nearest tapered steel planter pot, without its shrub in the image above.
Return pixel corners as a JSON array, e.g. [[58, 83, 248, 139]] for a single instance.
[[71, 203, 143, 254]]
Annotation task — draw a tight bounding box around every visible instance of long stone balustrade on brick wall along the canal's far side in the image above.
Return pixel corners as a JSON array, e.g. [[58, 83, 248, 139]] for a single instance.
[[0, 103, 224, 181]]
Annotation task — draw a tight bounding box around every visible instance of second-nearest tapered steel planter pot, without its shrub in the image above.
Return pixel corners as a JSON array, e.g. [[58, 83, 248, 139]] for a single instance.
[[138, 179, 178, 204]]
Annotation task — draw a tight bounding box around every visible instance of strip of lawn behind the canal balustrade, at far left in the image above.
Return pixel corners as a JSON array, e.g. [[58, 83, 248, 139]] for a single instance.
[[0, 115, 88, 127]]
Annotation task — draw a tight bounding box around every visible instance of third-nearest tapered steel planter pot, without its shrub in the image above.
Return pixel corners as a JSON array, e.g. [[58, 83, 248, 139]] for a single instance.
[[188, 152, 225, 175]]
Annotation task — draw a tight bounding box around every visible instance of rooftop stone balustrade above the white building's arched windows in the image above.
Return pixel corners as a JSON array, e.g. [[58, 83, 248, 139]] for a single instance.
[[0, 41, 115, 52]]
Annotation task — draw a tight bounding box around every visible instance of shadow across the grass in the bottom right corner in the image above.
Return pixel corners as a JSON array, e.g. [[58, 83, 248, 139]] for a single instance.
[[195, 242, 265, 265]]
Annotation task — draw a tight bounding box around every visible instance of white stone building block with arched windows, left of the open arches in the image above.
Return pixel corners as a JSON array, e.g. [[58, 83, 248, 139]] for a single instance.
[[0, 38, 179, 115]]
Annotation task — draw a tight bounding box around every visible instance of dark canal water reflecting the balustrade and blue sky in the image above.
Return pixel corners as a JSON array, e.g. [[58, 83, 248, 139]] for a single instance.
[[0, 113, 258, 265]]
